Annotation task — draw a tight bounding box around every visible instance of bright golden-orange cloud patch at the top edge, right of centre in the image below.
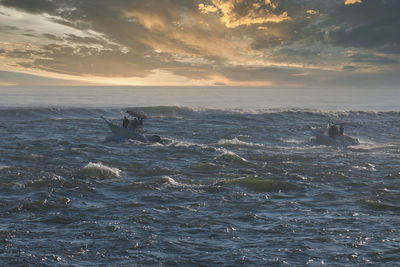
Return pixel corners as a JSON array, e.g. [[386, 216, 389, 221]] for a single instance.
[[198, 0, 292, 28]]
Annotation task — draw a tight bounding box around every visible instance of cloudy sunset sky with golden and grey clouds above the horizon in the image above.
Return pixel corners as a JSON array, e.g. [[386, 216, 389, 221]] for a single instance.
[[0, 0, 400, 87]]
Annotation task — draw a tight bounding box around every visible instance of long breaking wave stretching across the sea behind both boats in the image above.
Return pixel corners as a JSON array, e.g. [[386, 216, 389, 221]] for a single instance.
[[0, 106, 400, 120]]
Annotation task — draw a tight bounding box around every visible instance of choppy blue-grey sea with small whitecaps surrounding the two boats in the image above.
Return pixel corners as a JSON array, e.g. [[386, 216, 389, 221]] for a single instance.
[[0, 86, 400, 266]]
